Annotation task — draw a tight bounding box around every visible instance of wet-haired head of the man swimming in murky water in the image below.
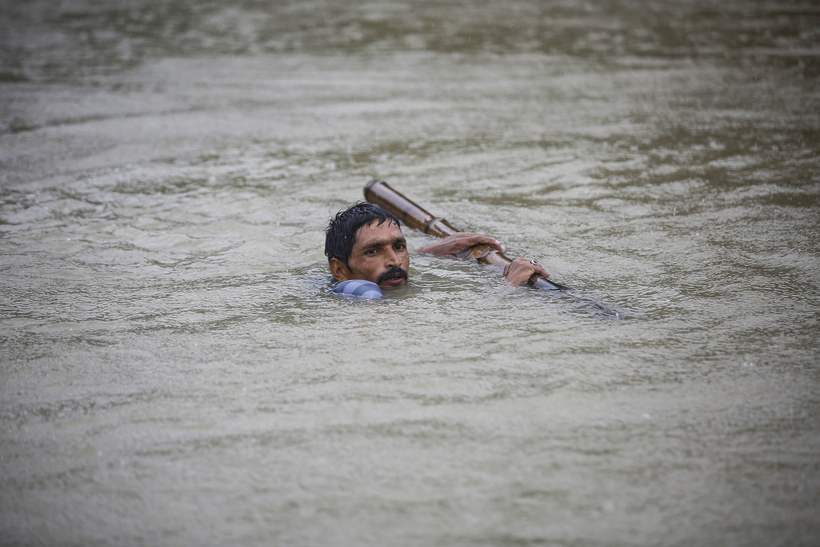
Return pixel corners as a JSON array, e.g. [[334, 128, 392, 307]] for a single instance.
[[325, 203, 410, 289]]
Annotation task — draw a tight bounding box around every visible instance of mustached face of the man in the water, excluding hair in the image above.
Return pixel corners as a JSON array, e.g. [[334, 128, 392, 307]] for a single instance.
[[330, 221, 410, 289]]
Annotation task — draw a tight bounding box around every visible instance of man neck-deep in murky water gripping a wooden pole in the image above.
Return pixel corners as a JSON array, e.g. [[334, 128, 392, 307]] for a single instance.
[[325, 203, 547, 298]]
